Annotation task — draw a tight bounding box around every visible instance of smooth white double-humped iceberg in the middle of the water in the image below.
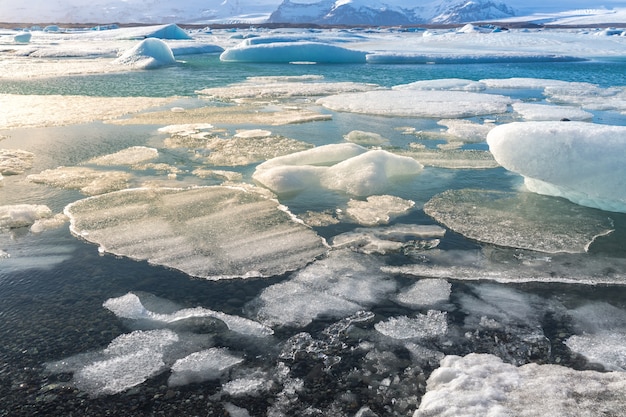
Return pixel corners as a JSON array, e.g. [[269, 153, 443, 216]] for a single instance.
[[252, 143, 422, 196]]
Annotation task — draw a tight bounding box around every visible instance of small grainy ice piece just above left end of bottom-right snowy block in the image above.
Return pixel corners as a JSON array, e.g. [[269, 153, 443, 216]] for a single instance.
[[374, 310, 448, 340]]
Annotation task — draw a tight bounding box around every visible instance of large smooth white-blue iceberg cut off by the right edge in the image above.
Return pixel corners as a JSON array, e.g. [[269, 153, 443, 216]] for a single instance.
[[487, 122, 626, 212]]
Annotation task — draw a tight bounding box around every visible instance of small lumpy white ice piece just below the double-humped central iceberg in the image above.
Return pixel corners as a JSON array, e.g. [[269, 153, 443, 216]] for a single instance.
[[346, 195, 415, 226]]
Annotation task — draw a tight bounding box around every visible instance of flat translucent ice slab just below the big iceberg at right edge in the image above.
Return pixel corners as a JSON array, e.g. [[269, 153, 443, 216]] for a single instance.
[[424, 189, 613, 253]]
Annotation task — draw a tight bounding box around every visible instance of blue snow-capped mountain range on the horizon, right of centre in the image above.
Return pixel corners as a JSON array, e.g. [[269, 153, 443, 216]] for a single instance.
[[269, 0, 516, 25]]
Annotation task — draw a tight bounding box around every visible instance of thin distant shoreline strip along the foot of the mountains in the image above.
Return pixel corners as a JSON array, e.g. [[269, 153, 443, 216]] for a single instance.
[[0, 22, 626, 29]]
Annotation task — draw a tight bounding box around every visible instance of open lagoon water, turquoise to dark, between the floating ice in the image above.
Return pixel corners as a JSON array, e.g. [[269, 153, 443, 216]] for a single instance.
[[0, 56, 626, 416]]
